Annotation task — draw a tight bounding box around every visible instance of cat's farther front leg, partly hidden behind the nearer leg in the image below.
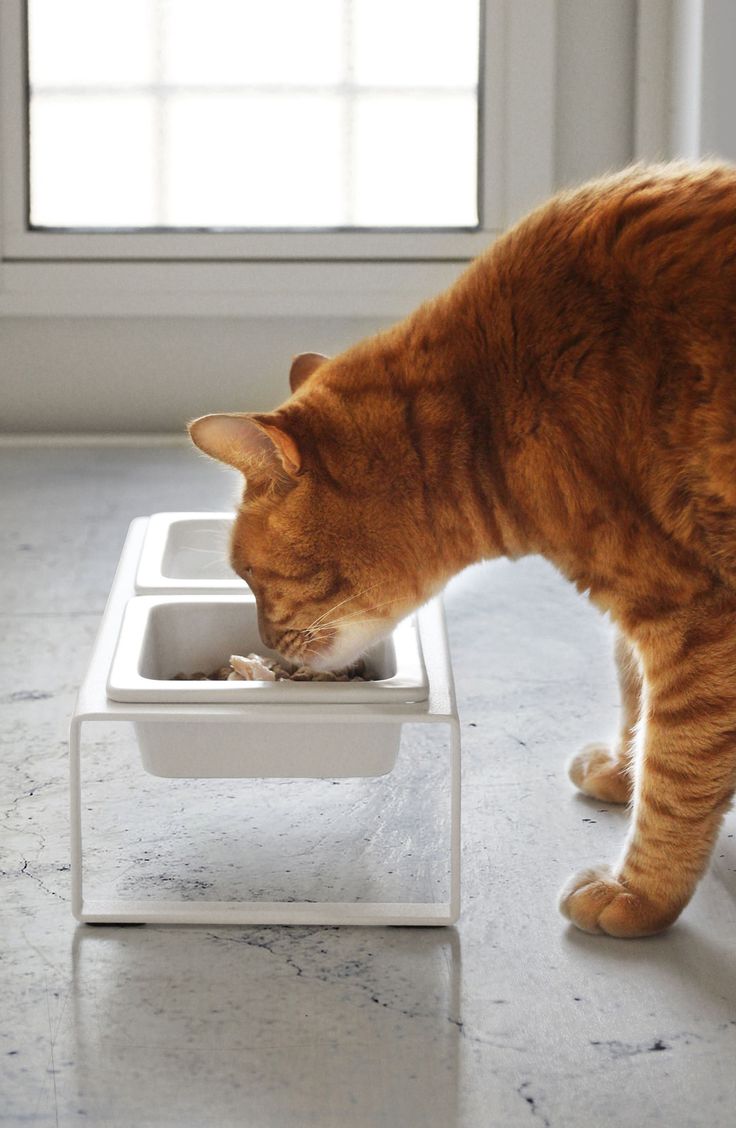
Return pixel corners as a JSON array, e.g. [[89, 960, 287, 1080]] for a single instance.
[[568, 633, 641, 803]]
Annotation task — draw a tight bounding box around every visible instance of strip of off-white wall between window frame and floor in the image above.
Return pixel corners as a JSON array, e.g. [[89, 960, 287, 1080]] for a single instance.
[[0, 317, 388, 432]]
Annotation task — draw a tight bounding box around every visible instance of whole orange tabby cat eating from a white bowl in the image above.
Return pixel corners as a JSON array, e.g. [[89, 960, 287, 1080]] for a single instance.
[[191, 165, 736, 936]]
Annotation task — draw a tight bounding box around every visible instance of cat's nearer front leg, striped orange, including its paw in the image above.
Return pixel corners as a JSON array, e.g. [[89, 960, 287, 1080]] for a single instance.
[[560, 609, 736, 936]]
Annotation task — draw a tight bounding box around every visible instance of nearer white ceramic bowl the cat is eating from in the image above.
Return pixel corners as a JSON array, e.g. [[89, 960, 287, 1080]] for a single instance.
[[107, 596, 428, 778]]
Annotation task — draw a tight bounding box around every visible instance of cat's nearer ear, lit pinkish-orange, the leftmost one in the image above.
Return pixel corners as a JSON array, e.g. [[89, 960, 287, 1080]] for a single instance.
[[189, 414, 301, 477]]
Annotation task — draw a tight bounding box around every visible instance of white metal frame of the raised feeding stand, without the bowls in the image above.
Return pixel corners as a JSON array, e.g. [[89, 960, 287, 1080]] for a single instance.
[[69, 518, 461, 926]]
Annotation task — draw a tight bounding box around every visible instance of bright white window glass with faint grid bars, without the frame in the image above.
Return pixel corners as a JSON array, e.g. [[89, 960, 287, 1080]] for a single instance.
[[28, 0, 480, 230]]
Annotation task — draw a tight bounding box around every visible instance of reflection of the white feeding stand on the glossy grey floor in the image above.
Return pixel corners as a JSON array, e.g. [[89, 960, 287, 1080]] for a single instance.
[[66, 926, 462, 1128]]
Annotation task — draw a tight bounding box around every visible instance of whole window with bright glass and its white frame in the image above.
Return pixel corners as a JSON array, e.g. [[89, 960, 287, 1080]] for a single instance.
[[0, 0, 555, 318]]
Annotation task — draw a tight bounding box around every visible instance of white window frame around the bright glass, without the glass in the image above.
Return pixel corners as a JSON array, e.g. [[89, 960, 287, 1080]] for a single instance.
[[0, 0, 555, 317]]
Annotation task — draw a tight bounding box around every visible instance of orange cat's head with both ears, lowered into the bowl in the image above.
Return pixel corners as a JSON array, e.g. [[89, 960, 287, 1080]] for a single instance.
[[190, 353, 444, 669]]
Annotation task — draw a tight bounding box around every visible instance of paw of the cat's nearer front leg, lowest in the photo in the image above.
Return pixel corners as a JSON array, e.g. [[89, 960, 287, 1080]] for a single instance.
[[559, 865, 680, 937]]
